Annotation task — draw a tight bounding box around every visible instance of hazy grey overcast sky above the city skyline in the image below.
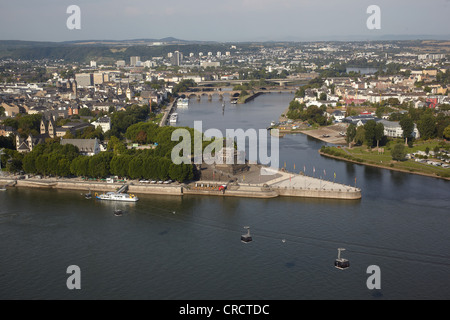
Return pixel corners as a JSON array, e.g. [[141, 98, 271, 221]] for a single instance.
[[0, 0, 450, 42]]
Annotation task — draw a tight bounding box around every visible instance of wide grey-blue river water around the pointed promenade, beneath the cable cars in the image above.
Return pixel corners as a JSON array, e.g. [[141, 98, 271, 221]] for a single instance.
[[0, 94, 450, 300]]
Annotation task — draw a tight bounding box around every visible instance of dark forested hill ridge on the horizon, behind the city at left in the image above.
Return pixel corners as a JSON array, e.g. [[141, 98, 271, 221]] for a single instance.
[[0, 40, 229, 64]]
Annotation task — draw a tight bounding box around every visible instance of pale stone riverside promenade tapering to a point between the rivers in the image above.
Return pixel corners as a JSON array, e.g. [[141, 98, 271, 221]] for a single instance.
[[0, 166, 361, 200]]
